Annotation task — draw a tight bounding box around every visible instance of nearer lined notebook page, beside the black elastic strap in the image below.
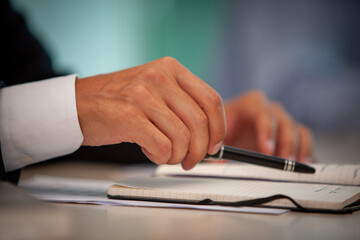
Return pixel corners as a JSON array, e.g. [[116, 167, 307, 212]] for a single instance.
[[108, 177, 360, 209]]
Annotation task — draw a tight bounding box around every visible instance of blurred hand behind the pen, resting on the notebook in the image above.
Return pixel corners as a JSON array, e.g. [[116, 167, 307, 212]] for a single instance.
[[224, 91, 312, 162]]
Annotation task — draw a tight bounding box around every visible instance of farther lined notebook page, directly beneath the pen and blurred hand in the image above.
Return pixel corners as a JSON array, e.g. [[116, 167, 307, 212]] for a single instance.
[[155, 163, 360, 186]]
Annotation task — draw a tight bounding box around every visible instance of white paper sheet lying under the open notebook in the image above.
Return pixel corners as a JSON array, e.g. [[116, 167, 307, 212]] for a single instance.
[[19, 176, 289, 215]]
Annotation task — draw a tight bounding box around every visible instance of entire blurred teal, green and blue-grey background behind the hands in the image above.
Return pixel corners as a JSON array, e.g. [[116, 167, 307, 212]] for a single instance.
[[12, 0, 360, 163]]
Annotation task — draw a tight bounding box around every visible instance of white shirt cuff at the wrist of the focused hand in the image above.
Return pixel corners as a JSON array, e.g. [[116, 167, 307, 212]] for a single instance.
[[0, 75, 83, 172]]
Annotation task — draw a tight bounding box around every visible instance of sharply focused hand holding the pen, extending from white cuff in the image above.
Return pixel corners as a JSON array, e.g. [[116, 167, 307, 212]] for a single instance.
[[76, 57, 226, 169]]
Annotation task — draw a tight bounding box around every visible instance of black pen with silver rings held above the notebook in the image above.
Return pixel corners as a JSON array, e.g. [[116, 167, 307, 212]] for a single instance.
[[204, 145, 315, 173]]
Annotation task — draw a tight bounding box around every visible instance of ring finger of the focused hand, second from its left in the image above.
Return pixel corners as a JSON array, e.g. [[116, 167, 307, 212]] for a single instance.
[[123, 81, 190, 164]]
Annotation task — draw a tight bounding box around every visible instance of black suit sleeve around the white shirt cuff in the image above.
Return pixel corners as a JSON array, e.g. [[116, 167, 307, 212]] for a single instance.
[[0, 0, 58, 183]]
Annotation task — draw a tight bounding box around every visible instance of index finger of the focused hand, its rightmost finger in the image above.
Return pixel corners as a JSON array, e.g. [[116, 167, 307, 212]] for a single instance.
[[177, 69, 226, 154]]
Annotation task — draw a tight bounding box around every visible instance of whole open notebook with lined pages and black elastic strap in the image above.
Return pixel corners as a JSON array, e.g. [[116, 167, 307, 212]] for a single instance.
[[108, 163, 360, 213]]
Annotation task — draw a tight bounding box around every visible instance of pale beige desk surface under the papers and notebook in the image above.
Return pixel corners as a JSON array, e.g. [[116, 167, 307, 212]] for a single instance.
[[0, 159, 360, 240]]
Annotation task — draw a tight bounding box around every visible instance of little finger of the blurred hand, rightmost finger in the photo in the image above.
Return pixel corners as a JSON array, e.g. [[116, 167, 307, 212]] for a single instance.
[[297, 125, 313, 163]]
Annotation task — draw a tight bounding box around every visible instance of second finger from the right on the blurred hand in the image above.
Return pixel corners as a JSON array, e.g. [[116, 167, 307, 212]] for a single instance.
[[272, 103, 296, 160]]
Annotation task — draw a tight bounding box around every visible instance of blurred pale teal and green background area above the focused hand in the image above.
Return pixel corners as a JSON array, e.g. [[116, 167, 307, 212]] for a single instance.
[[13, 0, 224, 87]]
